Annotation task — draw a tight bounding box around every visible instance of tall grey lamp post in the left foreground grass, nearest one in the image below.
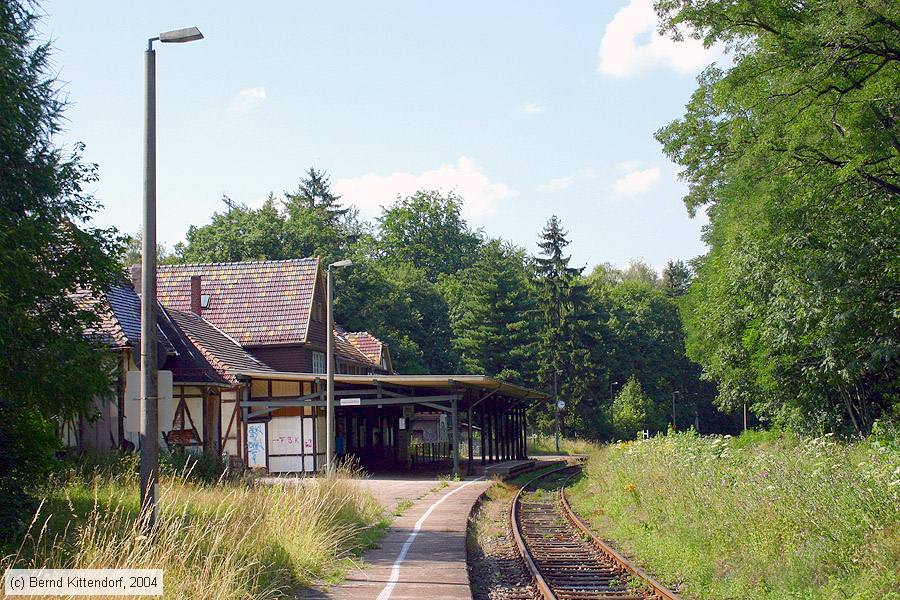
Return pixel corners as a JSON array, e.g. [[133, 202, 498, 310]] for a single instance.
[[140, 27, 203, 531]]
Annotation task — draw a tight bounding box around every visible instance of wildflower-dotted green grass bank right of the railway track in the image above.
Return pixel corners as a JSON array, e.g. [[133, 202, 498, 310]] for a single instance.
[[569, 432, 900, 600]]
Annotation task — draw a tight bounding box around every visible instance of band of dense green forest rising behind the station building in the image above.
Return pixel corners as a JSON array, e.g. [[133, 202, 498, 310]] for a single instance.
[[167, 183, 734, 439]]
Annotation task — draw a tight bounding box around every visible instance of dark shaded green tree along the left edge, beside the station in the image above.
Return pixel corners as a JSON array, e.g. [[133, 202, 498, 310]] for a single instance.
[[0, 0, 122, 537]]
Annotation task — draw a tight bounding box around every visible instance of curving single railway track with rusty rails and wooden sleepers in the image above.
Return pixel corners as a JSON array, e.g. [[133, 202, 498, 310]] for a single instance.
[[510, 466, 680, 600]]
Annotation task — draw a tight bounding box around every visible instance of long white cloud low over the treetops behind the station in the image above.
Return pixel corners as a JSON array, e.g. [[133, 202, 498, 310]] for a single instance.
[[334, 156, 518, 217]]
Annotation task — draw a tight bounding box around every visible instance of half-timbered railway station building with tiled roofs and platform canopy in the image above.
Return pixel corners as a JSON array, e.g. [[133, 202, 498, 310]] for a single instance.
[[63, 258, 547, 473]]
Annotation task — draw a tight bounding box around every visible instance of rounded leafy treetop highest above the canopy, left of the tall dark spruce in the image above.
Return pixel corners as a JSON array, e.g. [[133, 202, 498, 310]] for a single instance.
[[378, 191, 481, 283]]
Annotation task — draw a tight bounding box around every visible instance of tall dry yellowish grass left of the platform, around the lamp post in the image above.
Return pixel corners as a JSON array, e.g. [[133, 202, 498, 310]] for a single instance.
[[0, 454, 386, 599]]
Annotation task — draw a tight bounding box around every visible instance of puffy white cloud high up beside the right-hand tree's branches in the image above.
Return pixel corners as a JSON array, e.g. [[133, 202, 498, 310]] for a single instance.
[[599, 0, 722, 77]]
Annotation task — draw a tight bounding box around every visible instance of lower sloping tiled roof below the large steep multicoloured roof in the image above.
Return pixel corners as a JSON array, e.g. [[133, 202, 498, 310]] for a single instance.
[[168, 309, 273, 383]]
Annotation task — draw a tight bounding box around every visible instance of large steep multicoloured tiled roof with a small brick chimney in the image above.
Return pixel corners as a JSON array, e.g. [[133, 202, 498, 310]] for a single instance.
[[157, 258, 319, 346]]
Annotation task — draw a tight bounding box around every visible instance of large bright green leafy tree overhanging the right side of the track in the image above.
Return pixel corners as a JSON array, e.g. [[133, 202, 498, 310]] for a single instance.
[[657, 0, 900, 433]]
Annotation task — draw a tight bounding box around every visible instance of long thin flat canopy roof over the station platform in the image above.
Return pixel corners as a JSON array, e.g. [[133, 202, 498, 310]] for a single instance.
[[238, 371, 549, 400]]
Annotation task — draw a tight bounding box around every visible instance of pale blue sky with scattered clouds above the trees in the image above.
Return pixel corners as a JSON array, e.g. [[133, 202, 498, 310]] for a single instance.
[[41, 0, 716, 268]]
